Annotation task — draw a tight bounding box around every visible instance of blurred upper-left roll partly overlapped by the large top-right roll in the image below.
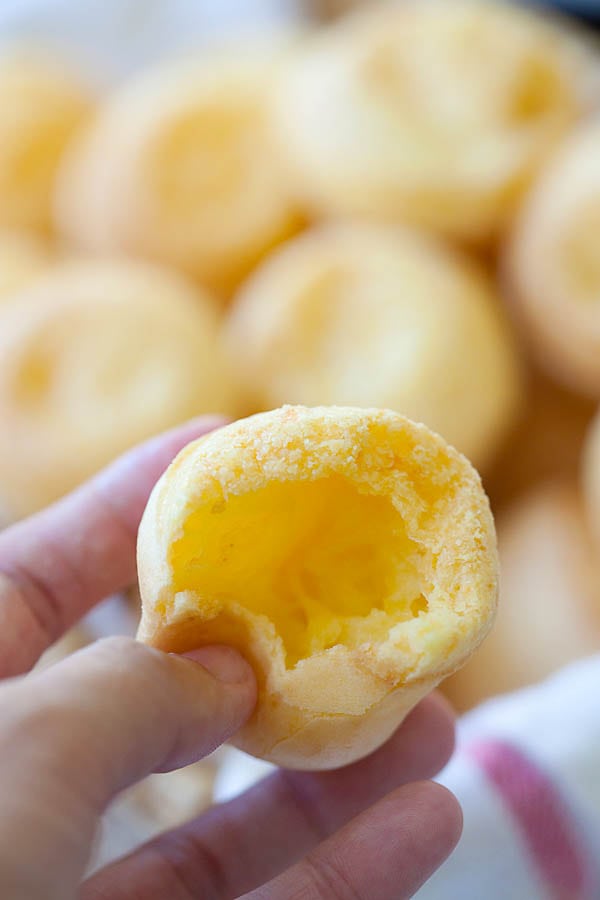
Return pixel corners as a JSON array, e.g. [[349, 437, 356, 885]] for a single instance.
[[56, 46, 297, 294]]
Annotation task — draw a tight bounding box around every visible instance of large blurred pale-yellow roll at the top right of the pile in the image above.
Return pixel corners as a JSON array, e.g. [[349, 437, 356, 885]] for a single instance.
[[274, 0, 591, 242]]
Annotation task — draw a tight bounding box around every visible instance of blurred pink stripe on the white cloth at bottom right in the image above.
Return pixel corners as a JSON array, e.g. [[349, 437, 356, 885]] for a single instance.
[[465, 740, 591, 900]]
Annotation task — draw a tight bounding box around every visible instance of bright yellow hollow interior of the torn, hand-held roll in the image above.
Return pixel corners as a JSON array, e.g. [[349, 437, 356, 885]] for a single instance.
[[169, 476, 428, 667]]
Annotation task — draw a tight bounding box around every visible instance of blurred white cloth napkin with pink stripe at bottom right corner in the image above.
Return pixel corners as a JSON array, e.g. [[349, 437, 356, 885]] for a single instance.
[[417, 656, 600, 900]]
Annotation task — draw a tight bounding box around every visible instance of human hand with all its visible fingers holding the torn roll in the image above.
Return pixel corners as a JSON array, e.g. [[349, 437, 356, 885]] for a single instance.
[[0, 420, 461, 900]]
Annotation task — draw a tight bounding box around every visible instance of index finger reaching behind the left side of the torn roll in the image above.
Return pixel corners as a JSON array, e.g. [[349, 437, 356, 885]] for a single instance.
[[0, 416, 224, 677]]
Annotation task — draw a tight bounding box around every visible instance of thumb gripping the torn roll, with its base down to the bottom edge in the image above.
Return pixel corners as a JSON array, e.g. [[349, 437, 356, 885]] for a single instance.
[[0, 638, 256, 900]]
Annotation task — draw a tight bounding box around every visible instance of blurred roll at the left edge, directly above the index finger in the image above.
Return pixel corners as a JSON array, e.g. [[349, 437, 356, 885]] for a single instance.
[[0, 261, 233, 516]]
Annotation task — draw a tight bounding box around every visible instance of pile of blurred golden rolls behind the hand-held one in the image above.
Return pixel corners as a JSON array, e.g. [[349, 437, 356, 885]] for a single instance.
[[0, 0, 600, 800]]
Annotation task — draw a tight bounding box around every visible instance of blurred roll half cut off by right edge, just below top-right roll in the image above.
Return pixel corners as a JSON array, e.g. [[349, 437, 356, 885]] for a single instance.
[[505, 119, 600, 397]]
